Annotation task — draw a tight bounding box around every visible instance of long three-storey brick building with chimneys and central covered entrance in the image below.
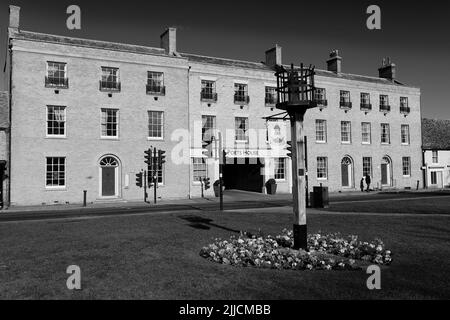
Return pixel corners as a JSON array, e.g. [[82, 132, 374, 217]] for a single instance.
[[0, 6, 422, 205]]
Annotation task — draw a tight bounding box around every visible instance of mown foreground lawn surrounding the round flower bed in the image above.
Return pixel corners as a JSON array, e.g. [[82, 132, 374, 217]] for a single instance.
[[0, 209, 450, 299]]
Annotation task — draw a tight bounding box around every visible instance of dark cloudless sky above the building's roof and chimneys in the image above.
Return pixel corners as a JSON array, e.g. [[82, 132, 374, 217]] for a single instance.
[[0, 0, 450, 119]]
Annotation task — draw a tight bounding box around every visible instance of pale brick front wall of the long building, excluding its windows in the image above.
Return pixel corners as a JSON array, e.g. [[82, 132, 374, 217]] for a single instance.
[[2, 6, 422, 205]]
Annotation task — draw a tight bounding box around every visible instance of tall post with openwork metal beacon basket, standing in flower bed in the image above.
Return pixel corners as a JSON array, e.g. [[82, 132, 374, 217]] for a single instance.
[[275, 63, 317, 250]]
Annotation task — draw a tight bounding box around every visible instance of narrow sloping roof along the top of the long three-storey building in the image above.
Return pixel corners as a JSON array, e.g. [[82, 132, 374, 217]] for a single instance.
[[12, 30, 412, 86]]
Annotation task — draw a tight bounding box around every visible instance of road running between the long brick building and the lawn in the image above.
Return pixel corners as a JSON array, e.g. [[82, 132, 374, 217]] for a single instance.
[[0, 191, 450, 222]]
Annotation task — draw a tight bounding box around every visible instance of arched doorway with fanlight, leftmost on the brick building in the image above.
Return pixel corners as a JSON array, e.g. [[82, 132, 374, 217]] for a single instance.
[[99, 155, 120, 198]]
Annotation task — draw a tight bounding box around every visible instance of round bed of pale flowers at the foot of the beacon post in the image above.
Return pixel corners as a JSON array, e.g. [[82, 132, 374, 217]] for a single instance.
[[200, 230, 392, 270]]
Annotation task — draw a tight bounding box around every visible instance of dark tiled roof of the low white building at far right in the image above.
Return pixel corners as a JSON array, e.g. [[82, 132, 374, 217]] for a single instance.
[[422, 119, 450, 150]]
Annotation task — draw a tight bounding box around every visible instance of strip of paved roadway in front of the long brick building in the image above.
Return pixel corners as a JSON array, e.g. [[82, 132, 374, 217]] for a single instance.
[[0, 190, 450, 222]]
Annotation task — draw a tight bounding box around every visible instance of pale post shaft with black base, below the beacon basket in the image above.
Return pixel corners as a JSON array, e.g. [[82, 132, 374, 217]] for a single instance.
[[291, 111, 307, 250]]
